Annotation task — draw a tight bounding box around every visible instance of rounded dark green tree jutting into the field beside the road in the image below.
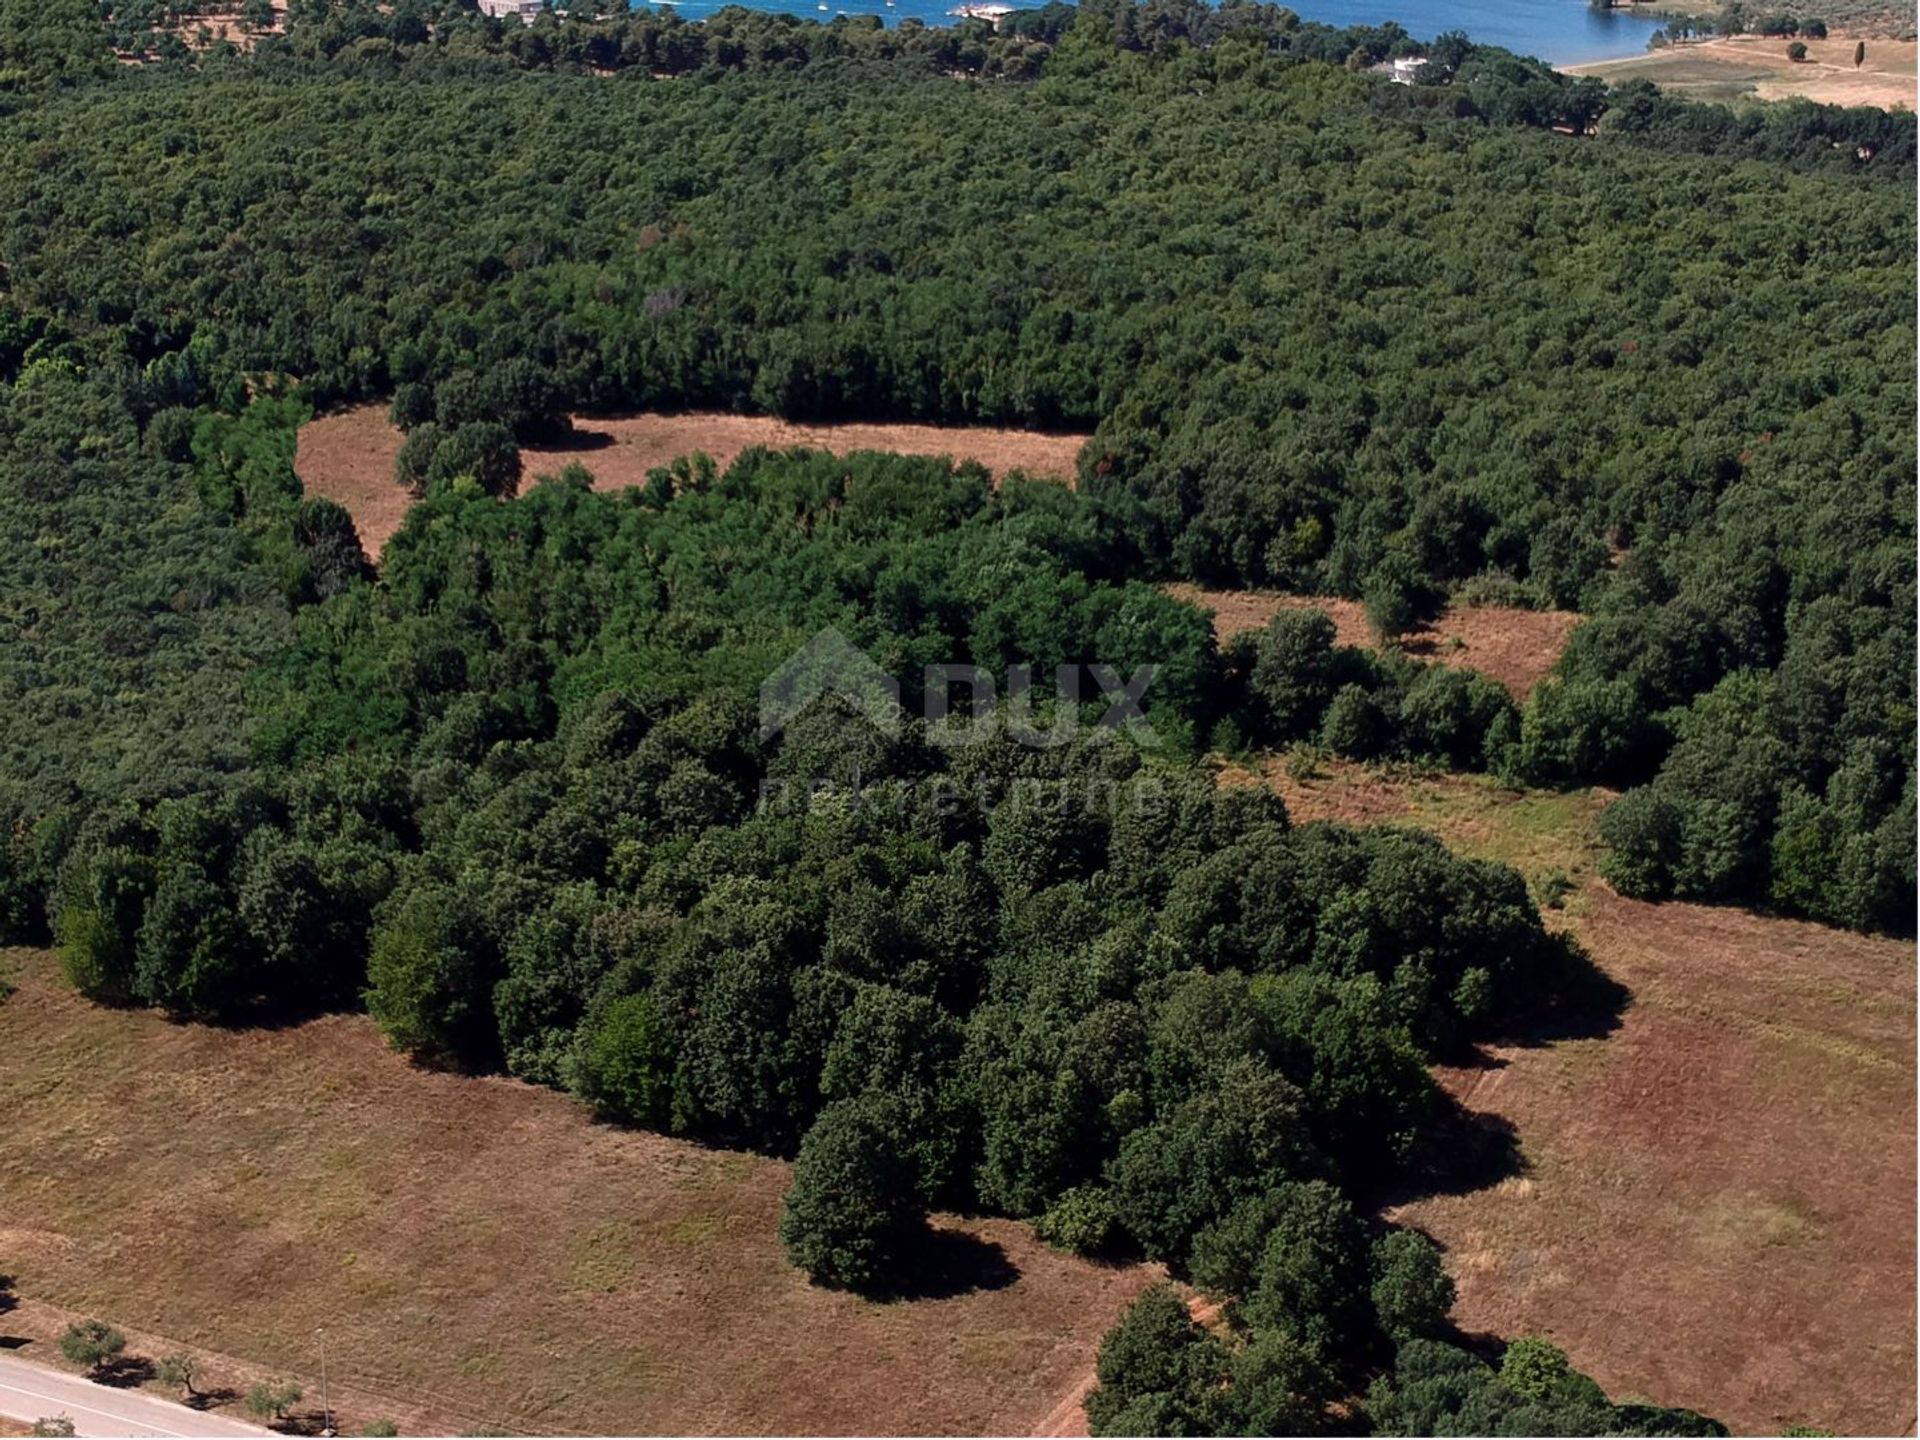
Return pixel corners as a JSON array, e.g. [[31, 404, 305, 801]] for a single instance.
[[780, 1096, 924, 1290]]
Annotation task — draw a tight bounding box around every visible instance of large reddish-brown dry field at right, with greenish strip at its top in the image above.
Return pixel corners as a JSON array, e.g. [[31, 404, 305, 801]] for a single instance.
[[1242, 762, 1916, 1434]]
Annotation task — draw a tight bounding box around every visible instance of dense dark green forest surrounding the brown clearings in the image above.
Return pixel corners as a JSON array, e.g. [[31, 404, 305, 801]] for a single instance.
[[0, 0, 1914, 1434]]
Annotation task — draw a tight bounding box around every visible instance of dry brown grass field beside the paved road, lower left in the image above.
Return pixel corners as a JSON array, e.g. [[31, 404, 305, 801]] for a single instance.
[[0, 950, 1150, 1434]]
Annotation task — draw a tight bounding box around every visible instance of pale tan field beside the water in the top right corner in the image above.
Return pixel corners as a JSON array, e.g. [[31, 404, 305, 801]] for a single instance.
[[1567, 35, 1916, 109]]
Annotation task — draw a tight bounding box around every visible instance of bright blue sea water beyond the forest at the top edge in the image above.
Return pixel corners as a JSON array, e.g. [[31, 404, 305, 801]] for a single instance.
[[634, 0, 1659, 65]]
